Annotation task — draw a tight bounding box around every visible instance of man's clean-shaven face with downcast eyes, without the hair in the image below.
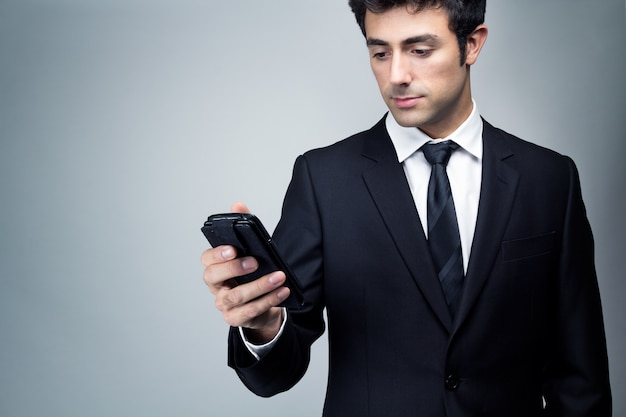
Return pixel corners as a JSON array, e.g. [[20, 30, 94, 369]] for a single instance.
[[365, 7, 472, 138]]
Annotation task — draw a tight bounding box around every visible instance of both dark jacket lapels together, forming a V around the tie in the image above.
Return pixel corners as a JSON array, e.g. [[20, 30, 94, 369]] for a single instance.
[[356, 119, 519, 329]]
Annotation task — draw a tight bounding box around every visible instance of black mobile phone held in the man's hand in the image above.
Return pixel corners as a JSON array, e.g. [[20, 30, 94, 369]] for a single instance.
[[202, 213, 304, 309]]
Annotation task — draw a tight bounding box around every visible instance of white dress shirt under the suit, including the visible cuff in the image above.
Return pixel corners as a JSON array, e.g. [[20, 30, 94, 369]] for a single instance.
[[244, 100, 483, 359]]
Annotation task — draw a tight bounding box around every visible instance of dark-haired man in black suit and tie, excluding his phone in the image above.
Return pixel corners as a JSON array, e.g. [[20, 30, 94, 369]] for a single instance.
[[203, 0, 611, 417]]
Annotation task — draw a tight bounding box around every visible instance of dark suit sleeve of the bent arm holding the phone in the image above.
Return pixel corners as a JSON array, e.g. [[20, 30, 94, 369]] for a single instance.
[[228, 156, 325, 397]]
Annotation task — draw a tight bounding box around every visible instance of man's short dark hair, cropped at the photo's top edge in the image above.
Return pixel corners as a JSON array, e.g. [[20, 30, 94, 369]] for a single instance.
[[348, 0, 487, 65]]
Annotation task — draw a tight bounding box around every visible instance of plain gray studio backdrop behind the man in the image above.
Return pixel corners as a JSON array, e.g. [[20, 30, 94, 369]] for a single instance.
[[0, 0, 626, 417]]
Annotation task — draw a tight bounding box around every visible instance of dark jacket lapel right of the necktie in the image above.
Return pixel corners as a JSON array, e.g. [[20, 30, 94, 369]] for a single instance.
[[455, 122, 519, 329]]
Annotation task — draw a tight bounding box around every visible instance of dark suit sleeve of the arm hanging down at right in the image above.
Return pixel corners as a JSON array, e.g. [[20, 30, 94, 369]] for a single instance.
[[544, 158, 612, 417]]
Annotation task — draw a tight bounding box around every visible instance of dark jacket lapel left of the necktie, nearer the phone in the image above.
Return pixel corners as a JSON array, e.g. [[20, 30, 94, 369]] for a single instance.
[[363, 119, 452, 329]]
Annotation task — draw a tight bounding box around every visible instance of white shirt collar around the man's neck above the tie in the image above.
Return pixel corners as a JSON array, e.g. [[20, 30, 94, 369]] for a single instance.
[[385, 100, 483, 163]]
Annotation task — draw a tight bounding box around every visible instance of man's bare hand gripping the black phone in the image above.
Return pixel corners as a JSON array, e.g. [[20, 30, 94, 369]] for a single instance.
[[202, 203, 289, 344]]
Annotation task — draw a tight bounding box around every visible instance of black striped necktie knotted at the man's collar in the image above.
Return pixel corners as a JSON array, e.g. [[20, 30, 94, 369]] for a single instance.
[[422, 141, 464, 317]]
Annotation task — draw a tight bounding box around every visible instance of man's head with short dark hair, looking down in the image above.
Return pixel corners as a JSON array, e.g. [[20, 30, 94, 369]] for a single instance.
[[350, 0, 487, 138]]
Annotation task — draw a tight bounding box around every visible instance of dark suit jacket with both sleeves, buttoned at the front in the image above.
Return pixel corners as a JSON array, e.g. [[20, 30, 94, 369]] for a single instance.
[[229, 119, 611, 417]]
